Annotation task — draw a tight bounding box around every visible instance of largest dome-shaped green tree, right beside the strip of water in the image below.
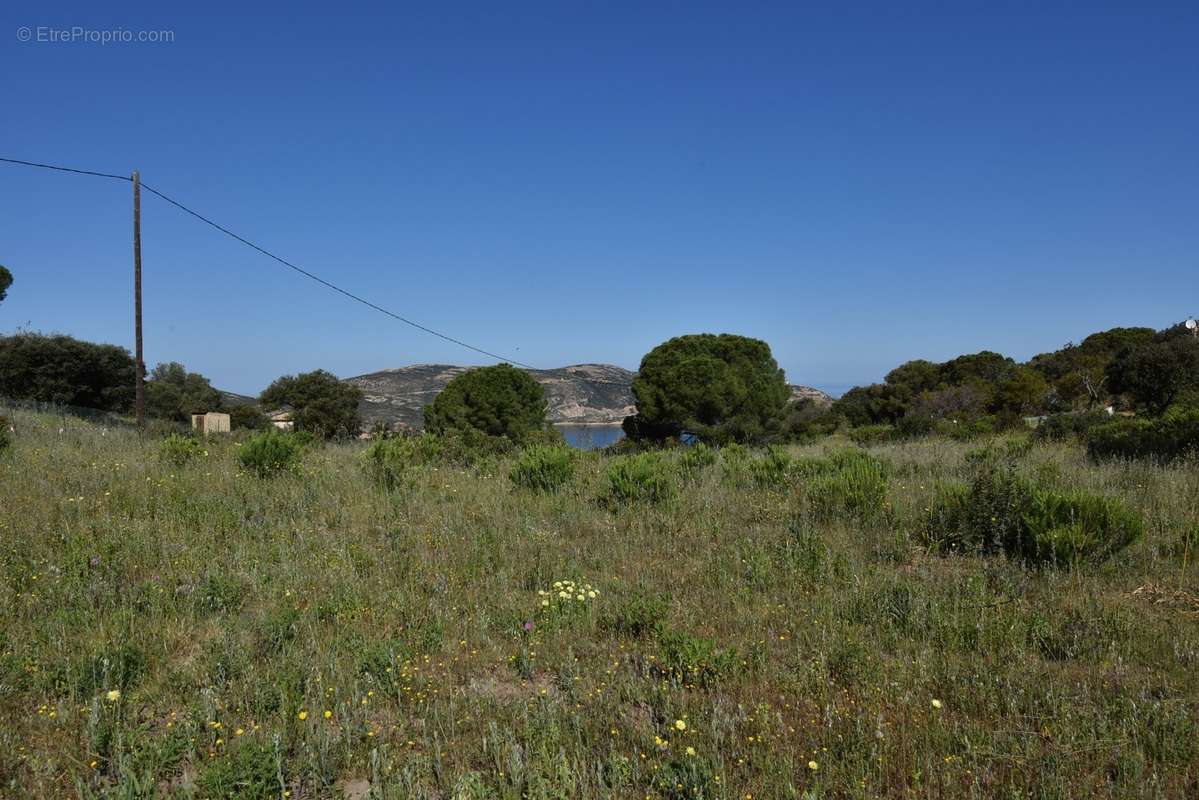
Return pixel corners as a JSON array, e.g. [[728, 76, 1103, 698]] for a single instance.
[[623, 333, 791, 444]]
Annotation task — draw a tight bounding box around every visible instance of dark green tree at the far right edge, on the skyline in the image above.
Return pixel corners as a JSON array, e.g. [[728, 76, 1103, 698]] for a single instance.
[[1107, 326, 1199, 414]]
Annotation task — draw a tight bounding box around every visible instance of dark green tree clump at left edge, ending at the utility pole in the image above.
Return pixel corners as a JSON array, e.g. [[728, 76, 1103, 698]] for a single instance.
[[0, 333, 133, 411]]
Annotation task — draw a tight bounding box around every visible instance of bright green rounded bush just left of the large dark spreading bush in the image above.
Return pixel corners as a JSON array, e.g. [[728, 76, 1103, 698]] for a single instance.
[[796, 450, 890, 518]]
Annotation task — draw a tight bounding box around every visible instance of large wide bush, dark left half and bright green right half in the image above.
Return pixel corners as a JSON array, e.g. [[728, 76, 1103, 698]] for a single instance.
[[924, 462, 1144, 566]]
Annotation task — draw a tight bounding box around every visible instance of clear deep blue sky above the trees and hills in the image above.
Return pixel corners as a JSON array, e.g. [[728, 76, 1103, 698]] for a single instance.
[[0, 0, 1199, 392]]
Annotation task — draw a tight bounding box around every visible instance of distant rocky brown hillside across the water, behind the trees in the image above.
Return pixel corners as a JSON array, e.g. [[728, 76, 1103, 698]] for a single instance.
[[347, 363, 832, 428]]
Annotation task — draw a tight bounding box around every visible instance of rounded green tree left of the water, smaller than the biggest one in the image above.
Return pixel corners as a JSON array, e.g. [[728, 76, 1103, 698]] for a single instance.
[[424, 363, 546, 444]]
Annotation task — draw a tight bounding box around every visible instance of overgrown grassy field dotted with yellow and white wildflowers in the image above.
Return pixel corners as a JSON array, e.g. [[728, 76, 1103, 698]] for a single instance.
[[0, 413, 1199, 800]]
